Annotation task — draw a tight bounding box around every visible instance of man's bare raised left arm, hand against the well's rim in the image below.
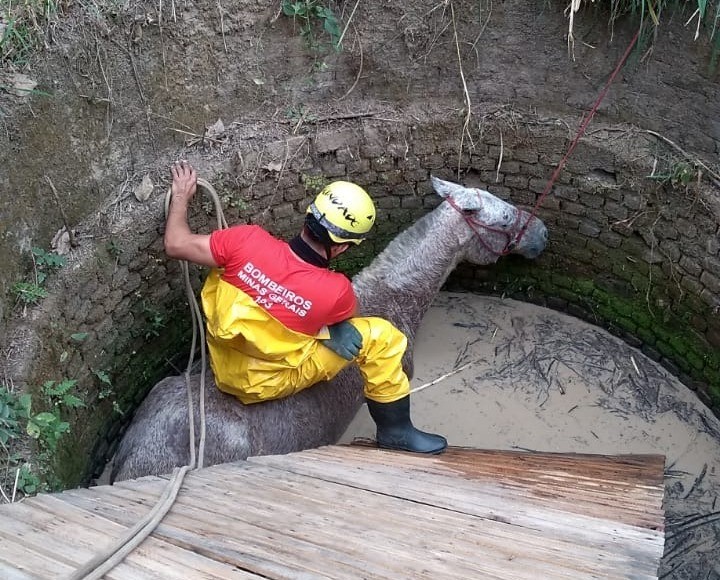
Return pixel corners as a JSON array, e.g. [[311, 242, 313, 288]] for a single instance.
[[164, 161, 218, 268]]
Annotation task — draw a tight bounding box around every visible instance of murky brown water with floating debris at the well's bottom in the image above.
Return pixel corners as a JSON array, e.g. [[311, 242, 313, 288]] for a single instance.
[[342, 293, 720, 580]]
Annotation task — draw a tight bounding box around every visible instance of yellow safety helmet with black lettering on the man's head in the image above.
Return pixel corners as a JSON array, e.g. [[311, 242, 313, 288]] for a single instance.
[[307, 181, 375, 244]]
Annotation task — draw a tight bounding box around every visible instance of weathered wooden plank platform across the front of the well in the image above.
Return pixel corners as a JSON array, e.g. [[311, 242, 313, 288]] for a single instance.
[[0, 446, 664, 580]]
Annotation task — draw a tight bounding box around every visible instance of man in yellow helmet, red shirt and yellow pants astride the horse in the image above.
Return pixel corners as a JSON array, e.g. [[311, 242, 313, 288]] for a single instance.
[[164, 161, 447, 453]]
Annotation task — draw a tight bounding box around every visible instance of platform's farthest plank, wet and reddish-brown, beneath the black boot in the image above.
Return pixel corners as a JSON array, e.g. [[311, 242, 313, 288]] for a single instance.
[[302, 446, 664, 529]]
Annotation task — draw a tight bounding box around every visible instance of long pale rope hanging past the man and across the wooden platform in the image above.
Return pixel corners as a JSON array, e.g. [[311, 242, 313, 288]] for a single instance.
[[67, 178, 228, 580]]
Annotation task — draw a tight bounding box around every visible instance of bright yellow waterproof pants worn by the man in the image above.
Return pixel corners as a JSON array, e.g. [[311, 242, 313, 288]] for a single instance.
[[202, 270, 410, 404]]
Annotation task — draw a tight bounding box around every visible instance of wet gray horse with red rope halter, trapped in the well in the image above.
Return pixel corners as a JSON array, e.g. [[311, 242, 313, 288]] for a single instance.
[[111, 177, 547, 481]]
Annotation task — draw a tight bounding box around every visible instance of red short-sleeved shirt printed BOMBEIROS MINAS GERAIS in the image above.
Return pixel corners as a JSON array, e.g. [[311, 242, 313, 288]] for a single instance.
[[210, 225, 357, 335]]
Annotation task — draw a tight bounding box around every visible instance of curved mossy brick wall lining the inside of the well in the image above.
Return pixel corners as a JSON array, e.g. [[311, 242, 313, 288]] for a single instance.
[[2, 110, 720, 485]]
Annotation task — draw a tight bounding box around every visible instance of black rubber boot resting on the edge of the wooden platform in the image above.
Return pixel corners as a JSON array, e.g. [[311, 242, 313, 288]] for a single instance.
[[366, 395, 447, 454]]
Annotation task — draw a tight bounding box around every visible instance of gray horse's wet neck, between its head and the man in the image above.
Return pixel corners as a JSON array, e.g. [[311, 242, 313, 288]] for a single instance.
[[353, 203, 472, 326]]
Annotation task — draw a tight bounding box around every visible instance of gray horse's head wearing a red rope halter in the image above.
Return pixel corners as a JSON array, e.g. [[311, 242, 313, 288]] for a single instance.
[[431, 176, 548, 264]]
